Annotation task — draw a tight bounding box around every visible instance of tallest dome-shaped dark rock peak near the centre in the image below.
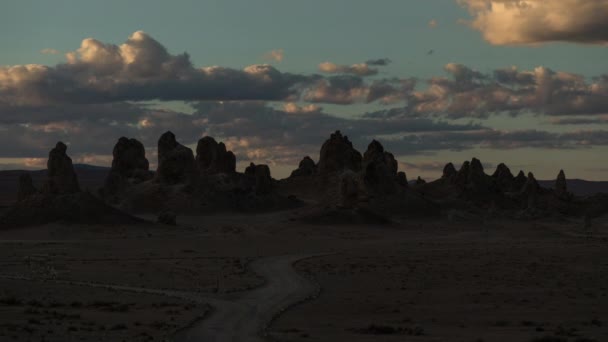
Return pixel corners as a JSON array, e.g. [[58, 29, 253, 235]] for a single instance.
[[318, 131, 362, 174]]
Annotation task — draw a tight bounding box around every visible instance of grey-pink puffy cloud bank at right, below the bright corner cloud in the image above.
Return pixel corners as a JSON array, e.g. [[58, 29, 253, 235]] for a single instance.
[[367, 63, 608, 118]]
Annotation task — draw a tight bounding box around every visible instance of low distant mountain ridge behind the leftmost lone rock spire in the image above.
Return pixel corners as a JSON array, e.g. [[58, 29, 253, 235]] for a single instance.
[[0, 164, 110, 207]]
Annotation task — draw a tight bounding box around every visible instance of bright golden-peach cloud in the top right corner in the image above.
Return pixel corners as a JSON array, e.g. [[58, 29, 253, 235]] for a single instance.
[[457, 0, 608, 45]]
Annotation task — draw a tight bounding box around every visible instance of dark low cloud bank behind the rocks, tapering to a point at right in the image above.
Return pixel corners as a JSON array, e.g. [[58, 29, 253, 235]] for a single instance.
[[0, 101, 481, 162]]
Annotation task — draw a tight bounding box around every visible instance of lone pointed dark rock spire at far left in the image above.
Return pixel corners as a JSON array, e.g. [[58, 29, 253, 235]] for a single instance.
[[43, 141, 80, 194]]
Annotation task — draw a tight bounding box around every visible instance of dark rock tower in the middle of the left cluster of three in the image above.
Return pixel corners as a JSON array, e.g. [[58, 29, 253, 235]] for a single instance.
[[156, 132, 196, 185]]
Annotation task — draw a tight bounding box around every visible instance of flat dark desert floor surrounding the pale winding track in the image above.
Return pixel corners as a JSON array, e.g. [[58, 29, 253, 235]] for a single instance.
[[0, 210, 608, 342]]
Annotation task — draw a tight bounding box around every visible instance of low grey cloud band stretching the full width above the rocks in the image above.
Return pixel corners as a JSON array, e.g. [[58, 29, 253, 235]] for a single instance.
[[0, 96, 608, 176]]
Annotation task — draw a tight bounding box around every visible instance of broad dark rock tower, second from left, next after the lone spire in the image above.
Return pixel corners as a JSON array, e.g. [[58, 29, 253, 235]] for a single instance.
[[101, 137, 152, 198]]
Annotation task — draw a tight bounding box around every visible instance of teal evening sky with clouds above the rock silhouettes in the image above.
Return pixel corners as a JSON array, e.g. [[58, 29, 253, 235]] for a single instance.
[[0, 0, 608, 180]]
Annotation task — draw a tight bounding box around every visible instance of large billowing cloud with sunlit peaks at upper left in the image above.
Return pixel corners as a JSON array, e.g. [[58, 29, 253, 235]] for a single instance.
[[0, 31, 315, 105]]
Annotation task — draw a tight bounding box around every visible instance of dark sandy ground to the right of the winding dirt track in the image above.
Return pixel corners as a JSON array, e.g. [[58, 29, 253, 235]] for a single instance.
[[272, 219, 608, 342]]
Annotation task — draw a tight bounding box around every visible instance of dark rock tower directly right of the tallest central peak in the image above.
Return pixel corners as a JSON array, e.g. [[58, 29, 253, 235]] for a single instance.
[[363, 140, 398, 194]]
